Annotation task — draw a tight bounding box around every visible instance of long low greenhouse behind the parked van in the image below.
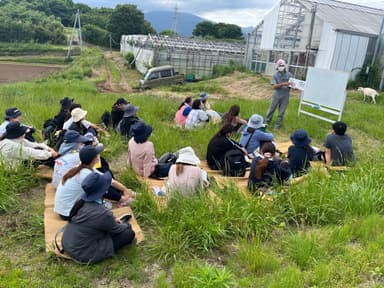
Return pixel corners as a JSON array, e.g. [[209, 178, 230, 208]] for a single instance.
[[120, 35, 245, 79]]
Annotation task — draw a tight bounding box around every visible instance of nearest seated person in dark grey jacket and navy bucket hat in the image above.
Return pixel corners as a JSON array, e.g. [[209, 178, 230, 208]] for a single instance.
[[61, 172, 135, 264]]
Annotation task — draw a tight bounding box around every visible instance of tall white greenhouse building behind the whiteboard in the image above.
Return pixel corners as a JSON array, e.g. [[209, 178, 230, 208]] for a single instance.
[[245, 0, 384, 85]]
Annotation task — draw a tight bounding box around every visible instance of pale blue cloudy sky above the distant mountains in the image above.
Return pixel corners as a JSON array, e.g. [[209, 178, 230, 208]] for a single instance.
[[74, 0, 384, 27]]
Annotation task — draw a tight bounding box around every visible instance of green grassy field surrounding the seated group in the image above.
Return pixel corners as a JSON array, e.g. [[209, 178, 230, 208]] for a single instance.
[[0, 49, 384, 288]]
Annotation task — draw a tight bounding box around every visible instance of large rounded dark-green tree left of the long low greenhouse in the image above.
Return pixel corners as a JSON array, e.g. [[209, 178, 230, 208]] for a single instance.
[[108, 4, 156, 47]]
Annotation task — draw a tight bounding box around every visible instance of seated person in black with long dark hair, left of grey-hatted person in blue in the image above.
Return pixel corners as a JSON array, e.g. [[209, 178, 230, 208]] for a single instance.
[[207, 124, 247, 170]]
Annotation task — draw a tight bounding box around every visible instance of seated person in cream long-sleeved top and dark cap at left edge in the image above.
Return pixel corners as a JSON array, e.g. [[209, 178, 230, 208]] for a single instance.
[[0, 122, 58, 168]]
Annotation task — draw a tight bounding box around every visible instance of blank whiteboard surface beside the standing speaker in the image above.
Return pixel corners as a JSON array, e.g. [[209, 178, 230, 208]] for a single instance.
[[302, 67, 349, 111]]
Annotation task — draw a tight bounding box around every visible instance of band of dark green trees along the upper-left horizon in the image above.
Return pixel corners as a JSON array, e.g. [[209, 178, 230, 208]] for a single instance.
[[0, 0, 155, 47]]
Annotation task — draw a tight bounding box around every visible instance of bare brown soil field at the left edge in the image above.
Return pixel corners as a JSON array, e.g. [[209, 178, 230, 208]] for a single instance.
[[0, 63, 61, 83]]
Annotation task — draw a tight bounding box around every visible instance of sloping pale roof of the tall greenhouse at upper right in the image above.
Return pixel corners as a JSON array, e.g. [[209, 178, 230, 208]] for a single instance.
[[298, 0, 384, 36]]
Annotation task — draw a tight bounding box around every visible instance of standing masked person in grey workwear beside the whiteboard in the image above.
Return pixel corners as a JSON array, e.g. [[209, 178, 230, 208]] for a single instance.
[[265, 59, 292, 129]]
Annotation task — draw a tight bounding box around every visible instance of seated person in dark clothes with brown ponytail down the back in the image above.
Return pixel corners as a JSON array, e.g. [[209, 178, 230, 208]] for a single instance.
[[248, 142, 291, 192]]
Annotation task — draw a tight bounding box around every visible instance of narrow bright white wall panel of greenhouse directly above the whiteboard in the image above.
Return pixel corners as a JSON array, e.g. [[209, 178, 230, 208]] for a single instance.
[[315, 23, 337, 69]]
